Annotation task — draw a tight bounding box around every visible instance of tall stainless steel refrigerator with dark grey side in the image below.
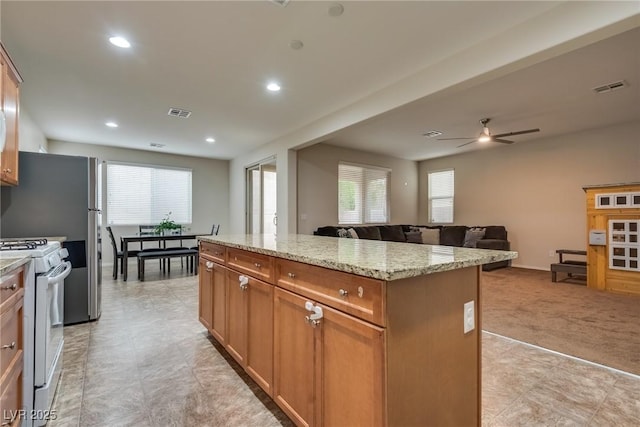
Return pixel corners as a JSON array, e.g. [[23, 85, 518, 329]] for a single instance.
[[0, 151, 102, 325]]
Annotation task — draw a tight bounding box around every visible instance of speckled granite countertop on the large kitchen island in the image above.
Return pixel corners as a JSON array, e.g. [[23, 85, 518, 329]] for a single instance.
[[198, 234, 518, 280]]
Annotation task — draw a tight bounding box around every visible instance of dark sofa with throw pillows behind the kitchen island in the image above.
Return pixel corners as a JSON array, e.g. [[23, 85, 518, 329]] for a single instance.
[[313, 225, 511, 271]]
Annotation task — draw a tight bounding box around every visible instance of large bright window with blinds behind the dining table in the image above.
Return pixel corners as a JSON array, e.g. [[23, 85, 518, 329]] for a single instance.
[[107, 162, 191, 225]]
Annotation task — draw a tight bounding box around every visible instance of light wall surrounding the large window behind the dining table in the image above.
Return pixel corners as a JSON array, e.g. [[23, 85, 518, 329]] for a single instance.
[[49, 141, 229, 265]]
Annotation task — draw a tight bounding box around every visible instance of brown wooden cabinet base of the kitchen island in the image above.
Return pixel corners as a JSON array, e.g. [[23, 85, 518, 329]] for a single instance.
[[200, 242, 481, 427]]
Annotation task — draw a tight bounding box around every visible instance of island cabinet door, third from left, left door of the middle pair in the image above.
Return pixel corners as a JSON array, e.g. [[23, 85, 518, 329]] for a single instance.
[[225, 270, 248, 368]]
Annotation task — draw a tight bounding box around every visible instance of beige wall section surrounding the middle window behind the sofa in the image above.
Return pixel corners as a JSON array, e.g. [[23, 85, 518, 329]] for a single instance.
[[297, 144, 418, 234]]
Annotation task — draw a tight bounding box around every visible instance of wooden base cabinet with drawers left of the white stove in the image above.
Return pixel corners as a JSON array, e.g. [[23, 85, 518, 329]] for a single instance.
[[0, 266, 25, 426]]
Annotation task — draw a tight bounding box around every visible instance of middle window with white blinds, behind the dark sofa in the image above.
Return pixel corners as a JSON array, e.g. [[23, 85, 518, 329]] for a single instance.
[[338, 162, 391, 224]]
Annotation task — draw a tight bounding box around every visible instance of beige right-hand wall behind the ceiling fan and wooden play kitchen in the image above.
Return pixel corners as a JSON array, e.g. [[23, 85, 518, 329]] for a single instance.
[[419, 118, 640, 270]]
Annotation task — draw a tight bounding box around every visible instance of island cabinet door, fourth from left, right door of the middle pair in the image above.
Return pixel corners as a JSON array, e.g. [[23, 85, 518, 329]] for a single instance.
[[245, 278, 273, 396]]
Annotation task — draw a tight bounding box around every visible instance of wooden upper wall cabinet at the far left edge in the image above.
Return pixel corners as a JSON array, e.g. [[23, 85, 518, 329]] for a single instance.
[[0, 42, 22, 185]]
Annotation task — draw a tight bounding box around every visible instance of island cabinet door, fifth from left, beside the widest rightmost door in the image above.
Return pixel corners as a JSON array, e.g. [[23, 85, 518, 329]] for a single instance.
[[273, 288, 316, 426]]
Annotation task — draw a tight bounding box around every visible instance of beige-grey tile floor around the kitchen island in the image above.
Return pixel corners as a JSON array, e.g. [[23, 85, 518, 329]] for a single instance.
[[48, 261, 640, 427]]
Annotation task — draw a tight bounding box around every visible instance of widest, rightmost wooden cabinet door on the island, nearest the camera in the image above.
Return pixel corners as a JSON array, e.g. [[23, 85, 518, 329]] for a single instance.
[[316, 306, 386, 427]]
